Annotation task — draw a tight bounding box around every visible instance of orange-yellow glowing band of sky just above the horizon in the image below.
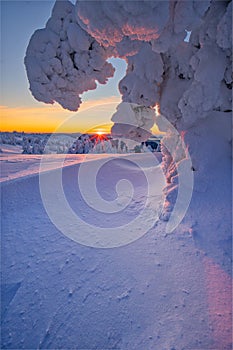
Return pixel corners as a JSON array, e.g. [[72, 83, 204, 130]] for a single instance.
[[0, 96, 164, 135]]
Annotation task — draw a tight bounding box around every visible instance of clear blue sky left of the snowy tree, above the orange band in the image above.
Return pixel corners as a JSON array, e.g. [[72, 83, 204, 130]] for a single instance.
[[0, 1, 53, 106]]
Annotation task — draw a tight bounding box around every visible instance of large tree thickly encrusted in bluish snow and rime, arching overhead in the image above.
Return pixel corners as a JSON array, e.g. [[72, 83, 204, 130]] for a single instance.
[[25, 0, 232, 246]]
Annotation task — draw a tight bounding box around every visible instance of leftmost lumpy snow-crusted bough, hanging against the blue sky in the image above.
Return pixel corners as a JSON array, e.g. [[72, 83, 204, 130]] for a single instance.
[[25, 1, 114, 111]]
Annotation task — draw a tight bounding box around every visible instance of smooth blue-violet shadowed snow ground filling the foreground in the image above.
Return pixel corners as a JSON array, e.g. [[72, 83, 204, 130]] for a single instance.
[[1, 154, 231, 350]]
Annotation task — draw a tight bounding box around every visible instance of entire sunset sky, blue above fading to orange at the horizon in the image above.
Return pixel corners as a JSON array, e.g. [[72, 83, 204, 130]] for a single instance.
[[0, 0, 162, 132]]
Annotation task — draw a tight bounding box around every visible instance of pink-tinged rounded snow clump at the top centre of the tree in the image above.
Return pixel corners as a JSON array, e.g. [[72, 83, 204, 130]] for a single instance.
[[76, 0, 169, 46]]
